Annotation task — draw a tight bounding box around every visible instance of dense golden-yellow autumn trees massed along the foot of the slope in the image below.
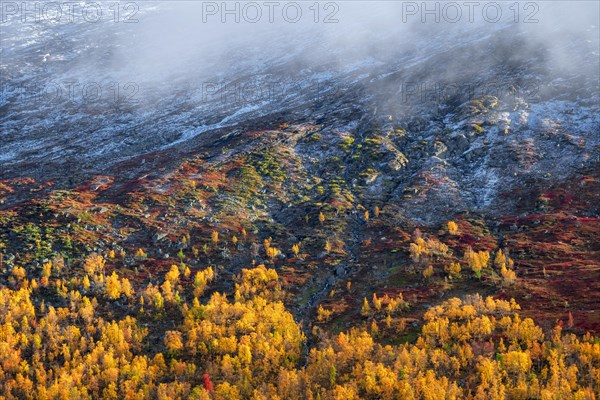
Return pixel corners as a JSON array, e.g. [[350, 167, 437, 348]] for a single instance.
[[0, 253, 600, 400]]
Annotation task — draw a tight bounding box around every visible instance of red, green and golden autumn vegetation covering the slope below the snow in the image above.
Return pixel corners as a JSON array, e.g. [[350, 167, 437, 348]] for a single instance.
[[0, 122, 600, 400]]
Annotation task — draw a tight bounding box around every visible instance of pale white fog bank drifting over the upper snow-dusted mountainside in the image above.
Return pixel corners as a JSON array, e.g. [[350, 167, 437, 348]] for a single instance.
[[105, 1, 599, 86]]
